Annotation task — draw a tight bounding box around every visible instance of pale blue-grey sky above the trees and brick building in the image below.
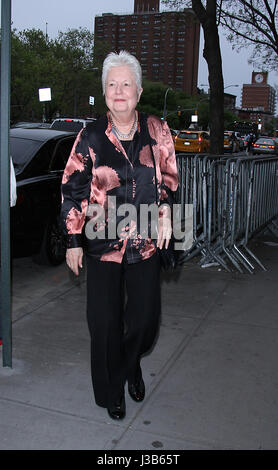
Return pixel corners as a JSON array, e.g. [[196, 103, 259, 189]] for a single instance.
[[0, 0, 278, 107]]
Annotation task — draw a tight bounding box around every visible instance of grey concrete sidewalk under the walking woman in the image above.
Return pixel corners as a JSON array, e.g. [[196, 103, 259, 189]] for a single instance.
[[0, 237, 278, 451]]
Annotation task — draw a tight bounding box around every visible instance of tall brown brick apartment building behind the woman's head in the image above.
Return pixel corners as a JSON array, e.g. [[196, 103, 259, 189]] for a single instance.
[[95, 0, 200, 95]]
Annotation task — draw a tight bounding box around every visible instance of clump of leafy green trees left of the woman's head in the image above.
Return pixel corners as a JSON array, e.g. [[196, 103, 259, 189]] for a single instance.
[[11, 28, 106, 121]]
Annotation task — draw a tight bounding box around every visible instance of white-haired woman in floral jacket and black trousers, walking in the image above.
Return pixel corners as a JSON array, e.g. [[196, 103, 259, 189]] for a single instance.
[[62, 51, 178, 419]]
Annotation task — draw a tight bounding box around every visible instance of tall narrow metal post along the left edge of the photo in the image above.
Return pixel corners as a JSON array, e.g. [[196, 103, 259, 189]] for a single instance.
[[0, 0, 12, 367]]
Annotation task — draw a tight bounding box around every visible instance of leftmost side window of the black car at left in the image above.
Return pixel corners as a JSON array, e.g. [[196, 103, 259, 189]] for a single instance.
[[10, 137, 42, 175]]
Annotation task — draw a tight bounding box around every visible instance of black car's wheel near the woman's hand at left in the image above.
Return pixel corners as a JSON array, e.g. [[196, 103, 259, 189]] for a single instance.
[[34, 216, 66, 266]]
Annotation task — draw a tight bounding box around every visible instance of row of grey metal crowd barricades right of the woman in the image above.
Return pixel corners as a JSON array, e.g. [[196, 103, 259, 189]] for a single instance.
[[177, 154, 278, 273]]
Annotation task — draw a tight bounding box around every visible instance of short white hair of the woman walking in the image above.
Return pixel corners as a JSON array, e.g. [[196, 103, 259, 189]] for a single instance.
[[101, 51, 142, 94]]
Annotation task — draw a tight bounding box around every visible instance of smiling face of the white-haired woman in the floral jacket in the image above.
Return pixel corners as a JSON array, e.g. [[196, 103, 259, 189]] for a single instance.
[[105, 65, 142, 114]]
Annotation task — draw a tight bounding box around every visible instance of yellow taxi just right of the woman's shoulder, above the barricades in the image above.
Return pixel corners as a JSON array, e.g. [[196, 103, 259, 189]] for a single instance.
[[174, 129, 210, 153]]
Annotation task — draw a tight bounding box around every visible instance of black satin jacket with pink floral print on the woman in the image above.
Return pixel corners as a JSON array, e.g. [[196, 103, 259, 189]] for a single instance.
[[61, 113, 178, 263]]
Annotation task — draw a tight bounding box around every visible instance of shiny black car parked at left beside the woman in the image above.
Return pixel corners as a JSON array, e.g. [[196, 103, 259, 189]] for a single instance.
[[10, 128, 77, 265]]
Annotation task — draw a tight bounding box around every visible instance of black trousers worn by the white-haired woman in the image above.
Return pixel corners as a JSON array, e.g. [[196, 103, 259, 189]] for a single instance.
[[86, 253, 160, 408]]
